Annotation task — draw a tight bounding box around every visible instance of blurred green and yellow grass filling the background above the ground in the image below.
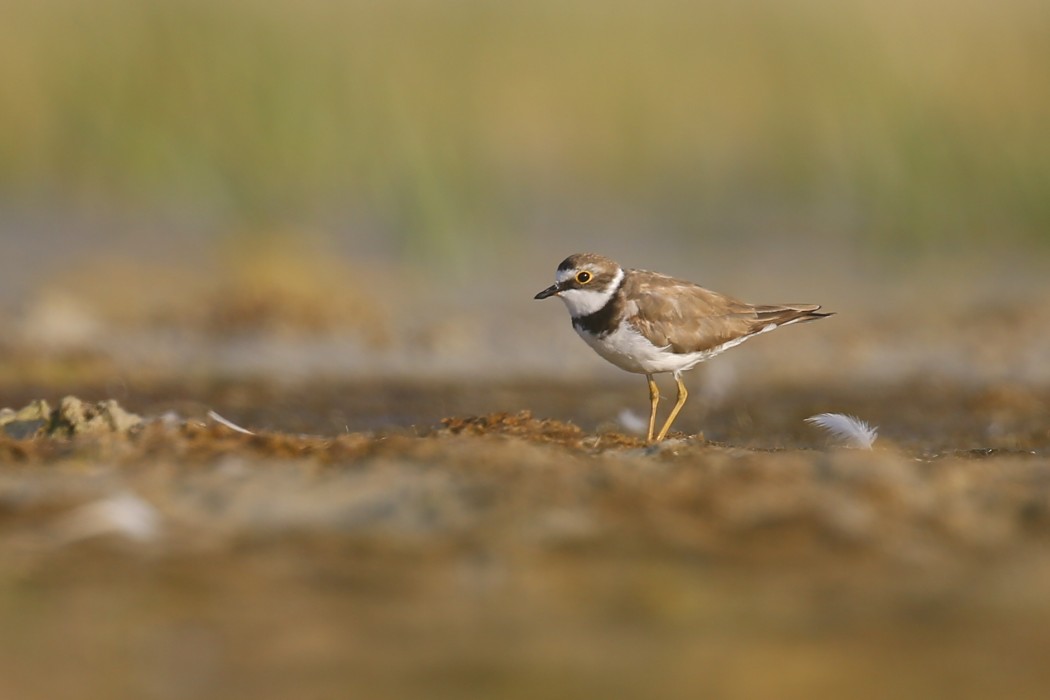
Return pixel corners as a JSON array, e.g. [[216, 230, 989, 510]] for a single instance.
[[0, 0, 1050, 255]]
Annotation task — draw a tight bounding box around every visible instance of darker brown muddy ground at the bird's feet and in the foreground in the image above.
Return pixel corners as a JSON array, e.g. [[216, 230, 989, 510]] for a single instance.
[[0, 380, 1050, 699]]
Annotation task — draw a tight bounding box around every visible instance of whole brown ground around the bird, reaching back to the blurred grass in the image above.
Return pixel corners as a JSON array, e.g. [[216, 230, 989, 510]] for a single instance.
[[0, 238, 1050, 700]]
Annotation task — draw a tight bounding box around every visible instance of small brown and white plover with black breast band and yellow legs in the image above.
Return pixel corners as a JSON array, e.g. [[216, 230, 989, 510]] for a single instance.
[[534, 253, 834, 444]]
